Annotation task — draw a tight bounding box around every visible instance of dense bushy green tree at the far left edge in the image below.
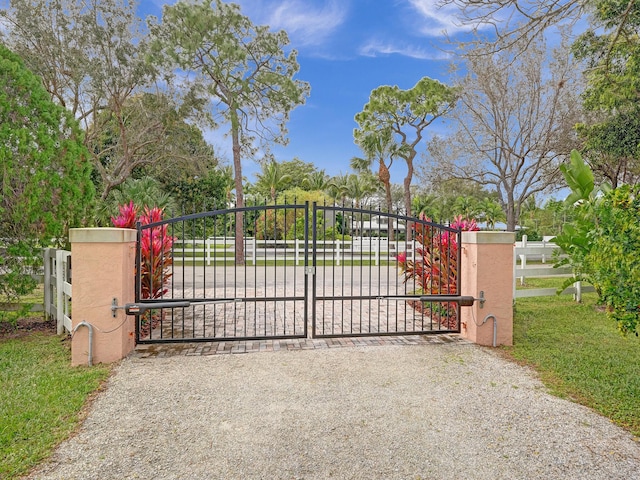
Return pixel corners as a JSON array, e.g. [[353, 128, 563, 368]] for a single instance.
[[0, 45, 94, 308]]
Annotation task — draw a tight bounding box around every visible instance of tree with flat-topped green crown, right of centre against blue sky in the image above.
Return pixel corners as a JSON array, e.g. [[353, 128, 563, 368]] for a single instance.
[[354, 77, 457, 219]]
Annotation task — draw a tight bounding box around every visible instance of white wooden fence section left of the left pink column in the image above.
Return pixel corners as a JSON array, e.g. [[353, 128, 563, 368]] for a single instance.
[[44, 248, 72, 335]]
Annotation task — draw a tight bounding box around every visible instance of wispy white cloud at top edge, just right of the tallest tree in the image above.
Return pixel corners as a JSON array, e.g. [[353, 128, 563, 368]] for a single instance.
[[240, 0, 349, 45]]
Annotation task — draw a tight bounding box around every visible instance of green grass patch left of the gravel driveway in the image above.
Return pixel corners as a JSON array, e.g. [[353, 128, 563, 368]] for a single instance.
[[0, 334, 110, 480]]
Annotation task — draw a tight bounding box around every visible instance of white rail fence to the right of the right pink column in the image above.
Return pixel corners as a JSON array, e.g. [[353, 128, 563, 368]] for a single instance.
[[513, 235, 594, 302]]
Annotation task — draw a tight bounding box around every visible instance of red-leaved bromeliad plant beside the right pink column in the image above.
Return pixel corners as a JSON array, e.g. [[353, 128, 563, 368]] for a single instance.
[[396, 214, 479, 330]]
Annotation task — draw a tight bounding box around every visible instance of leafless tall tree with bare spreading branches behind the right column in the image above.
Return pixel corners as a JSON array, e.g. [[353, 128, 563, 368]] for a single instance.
[[429, 40, 580, 231]]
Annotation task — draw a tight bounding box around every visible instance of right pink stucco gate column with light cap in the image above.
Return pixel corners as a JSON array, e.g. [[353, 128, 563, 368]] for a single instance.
[[460, 232, 515, 346]]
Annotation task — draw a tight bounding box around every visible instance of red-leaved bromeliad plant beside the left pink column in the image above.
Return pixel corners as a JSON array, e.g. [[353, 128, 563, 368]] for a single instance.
[[111, 202, 174, 298]]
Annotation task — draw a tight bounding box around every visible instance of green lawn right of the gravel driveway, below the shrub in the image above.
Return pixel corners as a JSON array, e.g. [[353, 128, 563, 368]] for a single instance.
[[505, 294, 640, 436]]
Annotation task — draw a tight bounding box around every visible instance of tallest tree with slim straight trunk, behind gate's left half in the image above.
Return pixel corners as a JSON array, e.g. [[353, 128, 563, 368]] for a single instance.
[[151, 0, 309, 263]]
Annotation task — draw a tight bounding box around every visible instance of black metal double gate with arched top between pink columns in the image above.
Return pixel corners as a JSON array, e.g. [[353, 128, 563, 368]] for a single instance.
[[134, 203, 464, 343]]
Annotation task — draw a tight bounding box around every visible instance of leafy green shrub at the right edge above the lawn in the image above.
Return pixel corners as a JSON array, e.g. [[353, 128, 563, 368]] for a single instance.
[[555, 151, 640, 335]]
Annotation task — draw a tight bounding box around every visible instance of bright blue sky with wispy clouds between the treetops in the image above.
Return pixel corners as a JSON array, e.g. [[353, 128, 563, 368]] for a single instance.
[[140, 0, 480, 183]]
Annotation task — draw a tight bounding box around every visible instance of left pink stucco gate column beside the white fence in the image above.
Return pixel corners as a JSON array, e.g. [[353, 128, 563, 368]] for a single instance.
[[69, 228, 136, 365]]
